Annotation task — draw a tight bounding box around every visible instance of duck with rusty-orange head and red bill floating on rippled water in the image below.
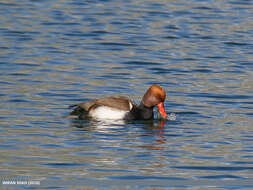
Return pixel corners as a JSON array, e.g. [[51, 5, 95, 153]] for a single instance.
[[69, 84, 167, 120]]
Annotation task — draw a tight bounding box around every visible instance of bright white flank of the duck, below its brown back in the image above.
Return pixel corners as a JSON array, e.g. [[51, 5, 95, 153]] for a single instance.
[[89, 106, 128, 120]]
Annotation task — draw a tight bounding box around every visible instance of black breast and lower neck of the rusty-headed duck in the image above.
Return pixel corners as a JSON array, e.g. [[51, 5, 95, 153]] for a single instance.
[[129, 102, 154, 120]]
